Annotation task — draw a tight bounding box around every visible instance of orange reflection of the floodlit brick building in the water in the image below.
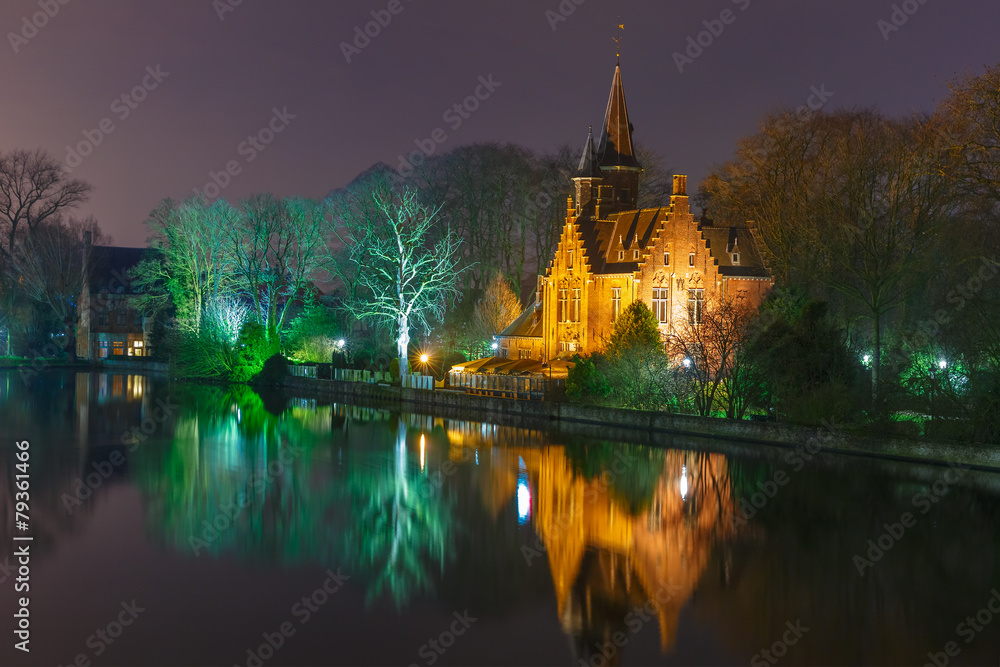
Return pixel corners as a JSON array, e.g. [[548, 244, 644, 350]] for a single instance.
[[448, 423, 732, 655]]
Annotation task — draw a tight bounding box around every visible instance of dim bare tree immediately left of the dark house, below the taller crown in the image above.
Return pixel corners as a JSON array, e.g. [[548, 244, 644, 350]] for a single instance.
[[12, 218, 110, 361]]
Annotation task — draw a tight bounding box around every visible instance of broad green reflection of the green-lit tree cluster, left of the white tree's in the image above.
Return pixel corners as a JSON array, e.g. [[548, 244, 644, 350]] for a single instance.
[[136, 386, 339, 564]]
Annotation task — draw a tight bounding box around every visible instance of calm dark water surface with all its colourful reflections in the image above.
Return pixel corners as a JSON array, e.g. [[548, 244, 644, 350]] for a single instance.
[[0, 372, 1000, 666]]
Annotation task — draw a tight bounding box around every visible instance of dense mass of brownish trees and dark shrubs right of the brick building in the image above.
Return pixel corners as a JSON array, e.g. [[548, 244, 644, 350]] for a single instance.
[[573, 67, 1000, 440]]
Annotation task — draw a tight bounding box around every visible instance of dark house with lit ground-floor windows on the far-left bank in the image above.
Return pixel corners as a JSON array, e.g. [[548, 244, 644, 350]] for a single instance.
[[76, 234, 154, 359]]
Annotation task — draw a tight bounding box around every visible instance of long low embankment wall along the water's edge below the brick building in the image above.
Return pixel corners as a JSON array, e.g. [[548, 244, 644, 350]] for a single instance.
[[281, 376, 1000, 472]]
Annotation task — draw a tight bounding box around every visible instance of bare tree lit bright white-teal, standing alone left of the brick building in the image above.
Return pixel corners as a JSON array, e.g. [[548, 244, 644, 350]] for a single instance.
[[336, 188, 462, 375]]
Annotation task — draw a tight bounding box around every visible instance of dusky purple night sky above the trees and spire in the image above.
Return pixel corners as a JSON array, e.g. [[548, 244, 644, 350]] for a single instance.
[[0, 0, 1000, 245]]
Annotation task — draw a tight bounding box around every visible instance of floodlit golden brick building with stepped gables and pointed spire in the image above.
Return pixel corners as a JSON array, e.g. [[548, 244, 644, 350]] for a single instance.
[[498, 65, 774, 361]]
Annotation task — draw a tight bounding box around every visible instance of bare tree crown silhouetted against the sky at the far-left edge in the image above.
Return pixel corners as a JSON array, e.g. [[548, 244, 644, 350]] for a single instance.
[[0, 149, 92, 258]]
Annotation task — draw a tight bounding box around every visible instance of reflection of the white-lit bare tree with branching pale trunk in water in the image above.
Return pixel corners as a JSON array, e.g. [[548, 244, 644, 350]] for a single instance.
[[345, 419, 453, 608]]
